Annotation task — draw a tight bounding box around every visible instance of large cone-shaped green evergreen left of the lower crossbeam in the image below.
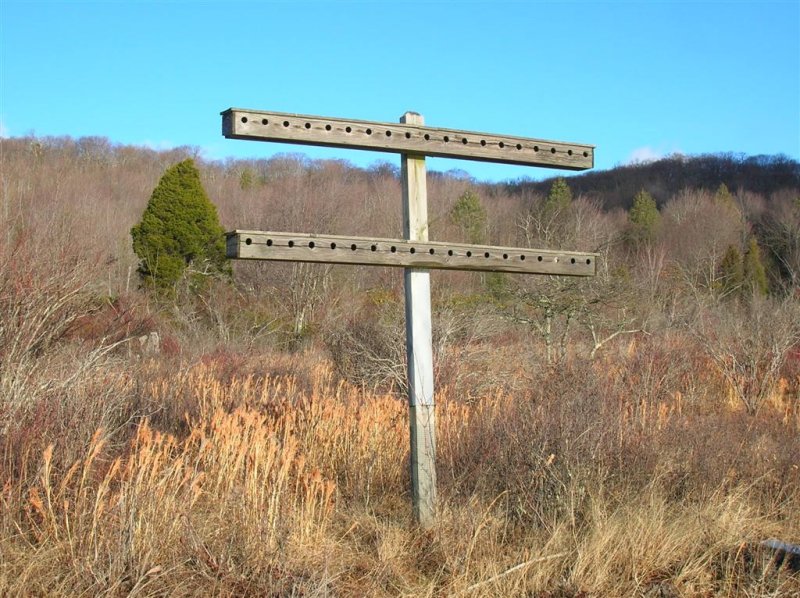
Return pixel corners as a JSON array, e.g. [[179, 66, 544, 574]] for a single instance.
[[131, 159, 230, 292]]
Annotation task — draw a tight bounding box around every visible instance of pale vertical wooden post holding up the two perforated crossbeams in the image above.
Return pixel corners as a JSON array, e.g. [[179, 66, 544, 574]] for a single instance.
[[400, 112, 436, 527]]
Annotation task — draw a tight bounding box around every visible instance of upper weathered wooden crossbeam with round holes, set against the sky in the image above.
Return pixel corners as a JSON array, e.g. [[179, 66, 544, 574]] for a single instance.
[[222, 108, 594, 170]]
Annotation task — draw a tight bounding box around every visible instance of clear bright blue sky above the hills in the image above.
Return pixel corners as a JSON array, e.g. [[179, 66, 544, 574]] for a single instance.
[[0, 0, 800, 180]]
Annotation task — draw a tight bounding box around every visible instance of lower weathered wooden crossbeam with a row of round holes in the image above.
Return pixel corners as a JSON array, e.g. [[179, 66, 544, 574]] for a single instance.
[[227, 230, 598, 276]]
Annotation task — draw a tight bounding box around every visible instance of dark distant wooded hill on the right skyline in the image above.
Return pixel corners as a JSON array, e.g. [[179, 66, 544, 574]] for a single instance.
[[505, 154, 800, 209]]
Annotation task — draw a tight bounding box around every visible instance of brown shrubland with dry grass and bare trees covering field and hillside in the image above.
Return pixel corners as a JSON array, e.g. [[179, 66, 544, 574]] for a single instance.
[[0, 139, 800, 597]]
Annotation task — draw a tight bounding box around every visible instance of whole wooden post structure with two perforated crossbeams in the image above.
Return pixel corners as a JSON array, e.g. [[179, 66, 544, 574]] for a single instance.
[[222, 108, 598, 527]]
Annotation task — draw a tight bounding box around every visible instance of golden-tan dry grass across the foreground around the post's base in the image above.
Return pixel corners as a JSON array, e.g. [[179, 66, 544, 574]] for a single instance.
[[0, 364, 800, 596]]
